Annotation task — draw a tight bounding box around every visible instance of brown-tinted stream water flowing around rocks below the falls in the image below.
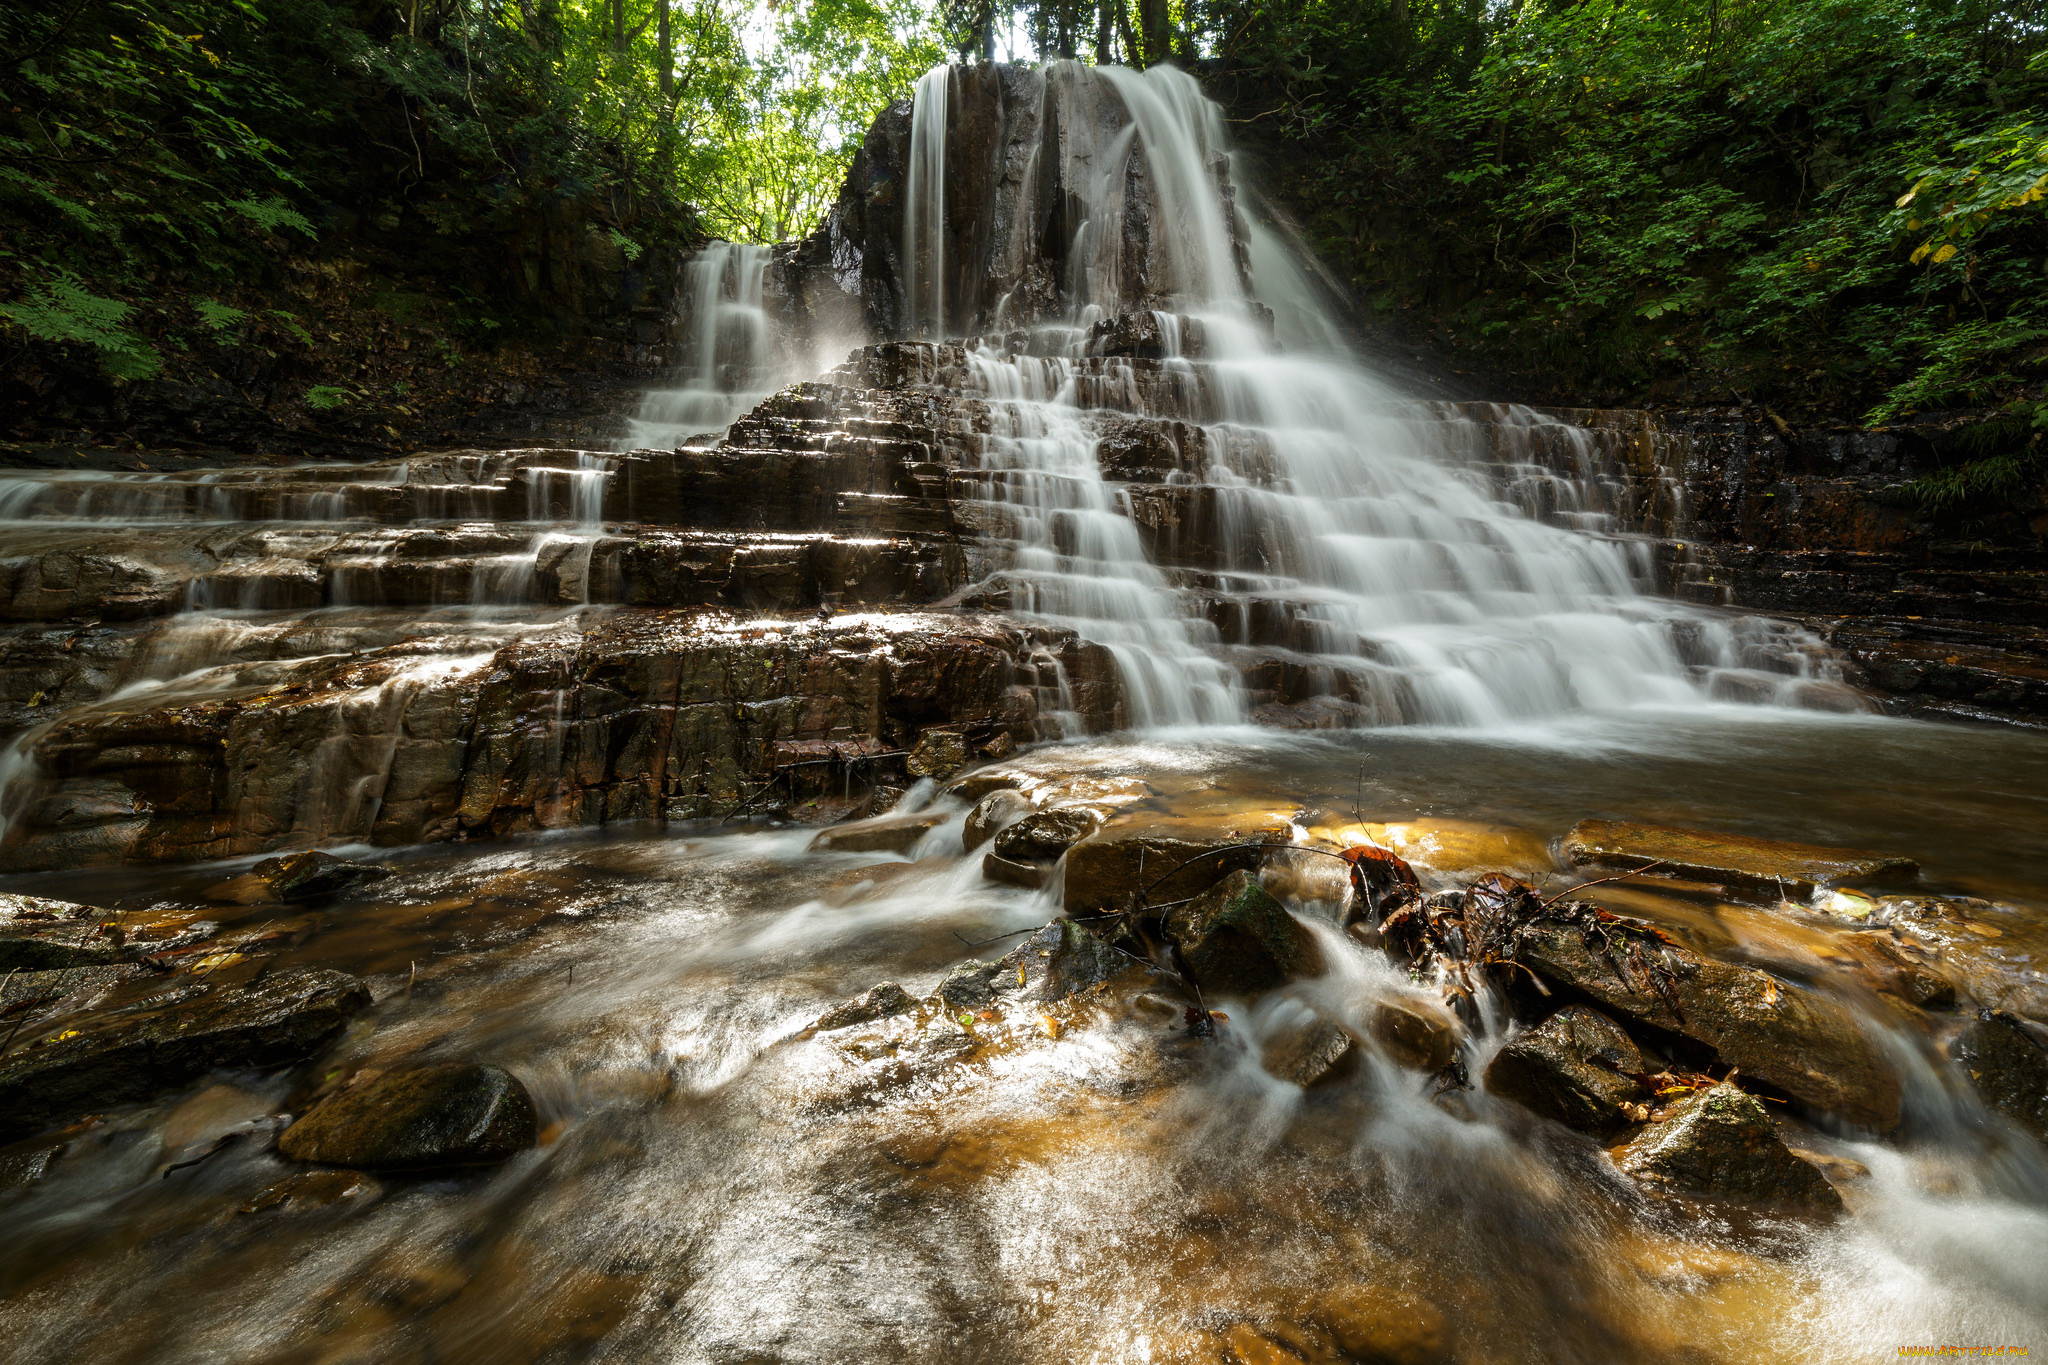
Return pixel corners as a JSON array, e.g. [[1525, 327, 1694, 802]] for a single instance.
[[0, 710, 2048, 1361]]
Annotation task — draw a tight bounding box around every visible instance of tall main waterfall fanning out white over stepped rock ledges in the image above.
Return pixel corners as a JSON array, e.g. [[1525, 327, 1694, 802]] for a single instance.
[[905, 63, 1812, 724]]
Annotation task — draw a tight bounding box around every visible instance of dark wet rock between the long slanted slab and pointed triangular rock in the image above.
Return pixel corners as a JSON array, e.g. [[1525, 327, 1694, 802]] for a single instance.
[[1487, 1005, 1647, 1134]]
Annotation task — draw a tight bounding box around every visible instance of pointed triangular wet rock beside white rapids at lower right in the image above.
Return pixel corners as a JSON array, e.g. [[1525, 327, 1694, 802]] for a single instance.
[[1614, 1085, 1841, 1212]]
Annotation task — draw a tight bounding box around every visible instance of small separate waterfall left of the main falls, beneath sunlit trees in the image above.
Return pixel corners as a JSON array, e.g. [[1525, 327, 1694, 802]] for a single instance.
[[621, 241, 776, 450]]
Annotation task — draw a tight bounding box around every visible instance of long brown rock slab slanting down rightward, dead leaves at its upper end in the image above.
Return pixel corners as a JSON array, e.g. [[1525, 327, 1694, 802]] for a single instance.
[[1518, 902, 1898, 1132]]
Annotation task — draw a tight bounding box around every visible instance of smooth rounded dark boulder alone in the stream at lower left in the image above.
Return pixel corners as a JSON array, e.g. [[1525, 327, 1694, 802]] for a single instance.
[[276, 1062, 539, 1171]]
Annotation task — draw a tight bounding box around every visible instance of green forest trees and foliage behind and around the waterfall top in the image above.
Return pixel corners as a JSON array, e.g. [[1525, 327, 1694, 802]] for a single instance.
[[0, 0, 2048, 458]]
